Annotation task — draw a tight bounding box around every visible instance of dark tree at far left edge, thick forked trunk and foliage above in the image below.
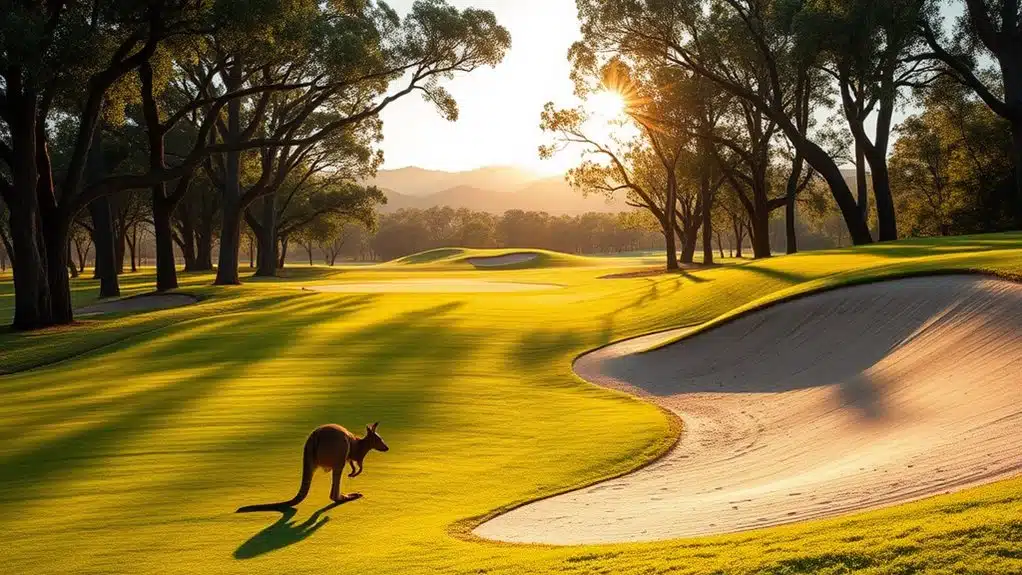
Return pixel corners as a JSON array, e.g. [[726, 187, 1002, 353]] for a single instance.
[[0, 0, 206, 329]]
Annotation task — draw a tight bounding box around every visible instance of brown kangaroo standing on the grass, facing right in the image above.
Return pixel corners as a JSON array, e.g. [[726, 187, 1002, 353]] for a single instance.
[[235, 422, 390, 513]]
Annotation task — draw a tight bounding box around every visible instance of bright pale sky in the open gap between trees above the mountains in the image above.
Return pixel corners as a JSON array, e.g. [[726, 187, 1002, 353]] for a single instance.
[[382, 0, 579, 173]]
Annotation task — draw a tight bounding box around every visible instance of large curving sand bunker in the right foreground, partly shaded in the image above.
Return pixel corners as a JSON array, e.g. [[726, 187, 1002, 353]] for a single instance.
[[475, 276, 1022, 544]]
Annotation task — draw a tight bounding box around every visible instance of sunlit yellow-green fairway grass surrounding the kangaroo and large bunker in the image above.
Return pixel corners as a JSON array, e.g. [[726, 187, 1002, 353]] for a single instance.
[[0, 235, 1022, 575]]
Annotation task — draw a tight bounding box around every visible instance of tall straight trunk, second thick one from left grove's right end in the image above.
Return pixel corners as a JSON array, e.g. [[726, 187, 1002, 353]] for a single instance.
[[214, 57, 243, 286]]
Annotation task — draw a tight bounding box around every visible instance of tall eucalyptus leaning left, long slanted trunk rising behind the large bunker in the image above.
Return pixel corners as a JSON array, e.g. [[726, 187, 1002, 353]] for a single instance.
[[578, 0, 872, 244]]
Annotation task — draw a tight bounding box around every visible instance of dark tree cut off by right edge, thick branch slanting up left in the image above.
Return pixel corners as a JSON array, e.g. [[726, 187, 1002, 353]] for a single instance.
[[919, 0, 1022, 223]]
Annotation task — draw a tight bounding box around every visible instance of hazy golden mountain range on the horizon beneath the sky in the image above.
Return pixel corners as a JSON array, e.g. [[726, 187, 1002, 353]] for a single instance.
[[369, 166, 629, 214]]
